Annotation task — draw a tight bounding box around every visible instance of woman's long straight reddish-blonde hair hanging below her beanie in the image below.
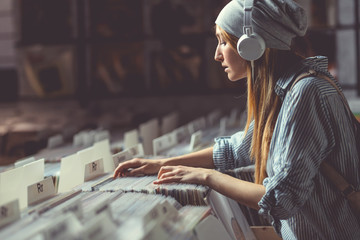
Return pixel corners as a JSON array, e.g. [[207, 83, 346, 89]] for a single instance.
[[217, 26, 301, 184]]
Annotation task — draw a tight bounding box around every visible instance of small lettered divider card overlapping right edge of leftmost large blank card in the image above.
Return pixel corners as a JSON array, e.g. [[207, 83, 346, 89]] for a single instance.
[[28, 177, 56, 205]]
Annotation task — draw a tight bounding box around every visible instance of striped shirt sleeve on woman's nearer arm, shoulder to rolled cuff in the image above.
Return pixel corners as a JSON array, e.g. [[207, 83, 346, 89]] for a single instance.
[[259, 78, 335, 222]]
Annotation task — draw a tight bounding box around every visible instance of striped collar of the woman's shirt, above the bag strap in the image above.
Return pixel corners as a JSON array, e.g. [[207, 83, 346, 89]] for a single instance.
[[274, 56, 330, 100]]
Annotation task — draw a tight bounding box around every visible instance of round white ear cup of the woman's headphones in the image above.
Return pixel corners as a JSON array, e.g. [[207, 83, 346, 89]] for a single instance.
[[237, 33, 265, 61]]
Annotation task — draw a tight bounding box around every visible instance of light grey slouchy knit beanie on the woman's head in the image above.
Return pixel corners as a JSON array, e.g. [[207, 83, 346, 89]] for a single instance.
[[215, 0, 307, 50]]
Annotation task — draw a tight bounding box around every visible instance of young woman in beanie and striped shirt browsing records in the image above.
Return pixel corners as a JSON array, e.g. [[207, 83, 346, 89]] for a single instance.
[[114, 0, 360, 240]]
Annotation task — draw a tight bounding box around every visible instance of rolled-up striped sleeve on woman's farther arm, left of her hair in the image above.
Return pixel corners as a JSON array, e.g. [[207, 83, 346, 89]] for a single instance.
[[213, 122, 254, 171]]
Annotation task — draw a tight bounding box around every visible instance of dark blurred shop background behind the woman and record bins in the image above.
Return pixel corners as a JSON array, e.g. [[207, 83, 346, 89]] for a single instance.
[[0, 0, 360, 164]]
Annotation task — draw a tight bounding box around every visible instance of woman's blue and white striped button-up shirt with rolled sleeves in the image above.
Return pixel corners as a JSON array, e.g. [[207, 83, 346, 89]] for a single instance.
[[213, 56, 360, 240]]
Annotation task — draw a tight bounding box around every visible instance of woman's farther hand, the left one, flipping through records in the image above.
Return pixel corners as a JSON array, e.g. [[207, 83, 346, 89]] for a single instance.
[[114, 158, 162, 178]]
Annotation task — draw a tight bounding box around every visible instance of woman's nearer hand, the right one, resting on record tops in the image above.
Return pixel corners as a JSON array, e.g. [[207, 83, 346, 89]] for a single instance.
[[154, 166, 218, 185]]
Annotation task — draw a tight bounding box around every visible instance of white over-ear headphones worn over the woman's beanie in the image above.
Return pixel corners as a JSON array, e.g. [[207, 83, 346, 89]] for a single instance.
[[237, 0, 265, 61]]
